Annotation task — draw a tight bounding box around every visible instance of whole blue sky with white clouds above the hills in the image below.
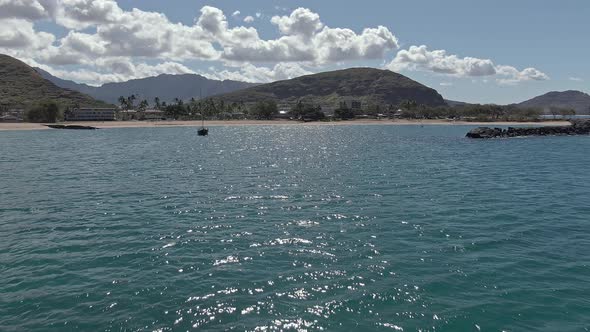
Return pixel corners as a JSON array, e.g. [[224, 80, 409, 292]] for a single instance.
[[0, 0, 590, 104]]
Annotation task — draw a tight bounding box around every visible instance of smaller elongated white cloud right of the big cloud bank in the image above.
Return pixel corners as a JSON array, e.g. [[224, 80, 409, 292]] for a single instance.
[[386, 45, 549, 84]]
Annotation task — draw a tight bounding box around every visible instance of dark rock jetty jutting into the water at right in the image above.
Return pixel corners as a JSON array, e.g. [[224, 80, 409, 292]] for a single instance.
[[465, 119, 590, 138]]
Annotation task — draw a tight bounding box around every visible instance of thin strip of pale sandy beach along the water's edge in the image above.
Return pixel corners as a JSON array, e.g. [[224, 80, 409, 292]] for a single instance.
[[0, 119, 570, 131]]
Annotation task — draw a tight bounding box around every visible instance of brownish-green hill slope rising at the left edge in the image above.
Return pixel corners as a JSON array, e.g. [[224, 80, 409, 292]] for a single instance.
[[0, 54, 106, 107]]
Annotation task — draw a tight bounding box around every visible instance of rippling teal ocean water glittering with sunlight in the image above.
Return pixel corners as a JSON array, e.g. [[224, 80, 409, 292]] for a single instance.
[[0, 125, 590, 331]]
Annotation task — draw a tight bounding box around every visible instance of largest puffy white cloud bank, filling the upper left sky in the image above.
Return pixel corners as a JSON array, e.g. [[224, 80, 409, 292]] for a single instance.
[[0, 0, 398, 81]]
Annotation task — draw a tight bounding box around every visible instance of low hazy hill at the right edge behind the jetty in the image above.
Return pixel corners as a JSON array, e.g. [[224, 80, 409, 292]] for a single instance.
[[517, 90, 590, 114]]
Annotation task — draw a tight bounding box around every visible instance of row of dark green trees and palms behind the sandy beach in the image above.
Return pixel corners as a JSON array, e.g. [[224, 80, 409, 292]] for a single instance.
[[119, 95, 576, 121]]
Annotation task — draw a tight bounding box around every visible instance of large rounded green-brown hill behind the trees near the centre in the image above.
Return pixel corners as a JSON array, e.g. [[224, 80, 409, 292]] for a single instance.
[[218, 68, 446, 106]]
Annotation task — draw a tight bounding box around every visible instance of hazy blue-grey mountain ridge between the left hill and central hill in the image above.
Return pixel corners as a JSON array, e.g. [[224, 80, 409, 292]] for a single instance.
[[36, 68, 257, 104]]
